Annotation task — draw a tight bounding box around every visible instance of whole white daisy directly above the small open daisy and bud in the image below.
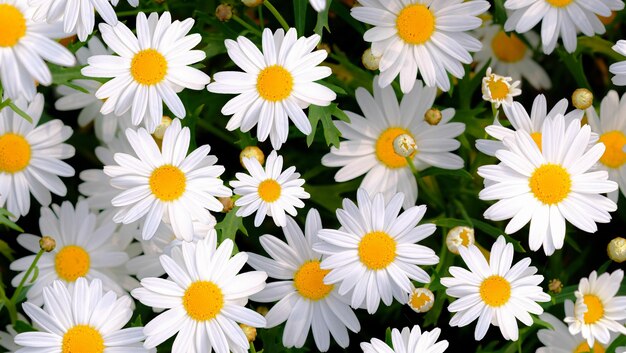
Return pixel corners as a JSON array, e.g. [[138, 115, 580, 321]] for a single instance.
[[207, 28, 337, 150]]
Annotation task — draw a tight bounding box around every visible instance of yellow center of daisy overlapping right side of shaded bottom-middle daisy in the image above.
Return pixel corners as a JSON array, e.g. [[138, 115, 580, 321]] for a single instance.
[[359, 232, 396, 270]]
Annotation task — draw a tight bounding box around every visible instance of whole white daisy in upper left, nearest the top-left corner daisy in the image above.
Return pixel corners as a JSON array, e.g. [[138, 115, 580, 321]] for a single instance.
[[81, 12, 210, 133]]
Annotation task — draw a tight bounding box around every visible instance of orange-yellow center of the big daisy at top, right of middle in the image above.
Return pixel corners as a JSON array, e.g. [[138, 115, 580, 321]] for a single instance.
[[396, 4, 435, 45]]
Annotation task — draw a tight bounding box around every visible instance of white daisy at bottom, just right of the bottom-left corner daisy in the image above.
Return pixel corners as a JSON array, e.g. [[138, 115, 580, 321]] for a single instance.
[[132, 234, 267, 353]]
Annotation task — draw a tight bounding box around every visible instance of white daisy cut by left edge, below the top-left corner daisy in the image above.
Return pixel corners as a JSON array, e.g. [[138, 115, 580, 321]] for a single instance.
[[0, 93, 75, 219]]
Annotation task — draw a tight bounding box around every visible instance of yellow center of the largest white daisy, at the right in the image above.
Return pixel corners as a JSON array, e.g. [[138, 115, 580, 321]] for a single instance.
[[528, 163, 572, 205]]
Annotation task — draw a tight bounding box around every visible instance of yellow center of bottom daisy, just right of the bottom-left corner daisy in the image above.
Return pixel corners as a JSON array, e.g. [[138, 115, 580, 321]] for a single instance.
[[183, 281, 224, 321]]
